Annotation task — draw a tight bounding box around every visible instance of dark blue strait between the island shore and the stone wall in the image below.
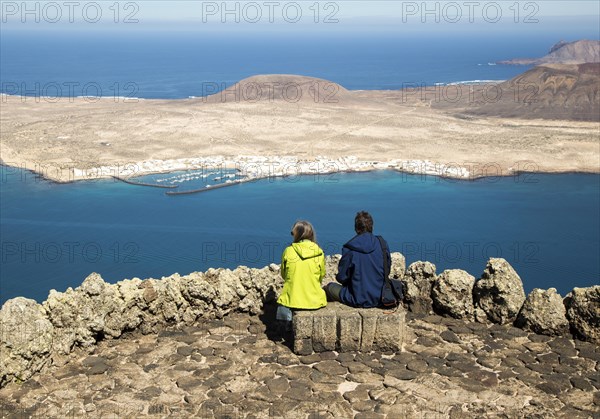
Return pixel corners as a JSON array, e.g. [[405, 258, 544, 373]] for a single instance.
[[0, 166, 600, 302]]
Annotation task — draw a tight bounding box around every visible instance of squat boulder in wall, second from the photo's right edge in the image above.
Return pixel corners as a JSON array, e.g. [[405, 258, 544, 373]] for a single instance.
[[515, 288, 569, 336]]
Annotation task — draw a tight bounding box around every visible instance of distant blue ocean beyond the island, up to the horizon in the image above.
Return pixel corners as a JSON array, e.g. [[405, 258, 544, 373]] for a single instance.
[[0, 31, 597, 98]]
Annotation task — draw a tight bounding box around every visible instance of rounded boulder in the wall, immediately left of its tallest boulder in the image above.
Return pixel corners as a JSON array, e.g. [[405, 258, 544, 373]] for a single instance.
[[431, 269, 475, 320]]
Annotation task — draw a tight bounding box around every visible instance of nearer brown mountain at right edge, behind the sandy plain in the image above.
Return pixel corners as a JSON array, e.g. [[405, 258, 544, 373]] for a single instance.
[[434, 63, 600, 121]]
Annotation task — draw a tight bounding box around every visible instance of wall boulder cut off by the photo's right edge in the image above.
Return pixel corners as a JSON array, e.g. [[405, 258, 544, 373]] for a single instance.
[[564, 285, 600, 344]]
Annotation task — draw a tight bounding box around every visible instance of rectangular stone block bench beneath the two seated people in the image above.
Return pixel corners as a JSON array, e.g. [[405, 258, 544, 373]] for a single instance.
[[293, 303, 406, 355]]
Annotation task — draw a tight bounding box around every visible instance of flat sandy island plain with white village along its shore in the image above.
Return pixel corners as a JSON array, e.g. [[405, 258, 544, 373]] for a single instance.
[[0, 79, 600, 182]]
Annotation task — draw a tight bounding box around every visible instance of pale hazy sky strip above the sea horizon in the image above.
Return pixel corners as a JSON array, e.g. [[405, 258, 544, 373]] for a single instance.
[[0, 0, 600, 31]]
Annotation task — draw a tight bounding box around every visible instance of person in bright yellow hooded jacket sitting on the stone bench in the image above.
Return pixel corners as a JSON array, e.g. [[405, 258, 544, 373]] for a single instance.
[[277, 221, 327, 320]]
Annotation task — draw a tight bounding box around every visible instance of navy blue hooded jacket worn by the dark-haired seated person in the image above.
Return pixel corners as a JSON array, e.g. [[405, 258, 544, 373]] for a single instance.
[[336, 233, 391, 307]]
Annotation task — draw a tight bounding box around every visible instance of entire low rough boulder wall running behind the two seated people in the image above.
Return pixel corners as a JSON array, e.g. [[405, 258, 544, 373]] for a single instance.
[[0, 253, 600, 387]]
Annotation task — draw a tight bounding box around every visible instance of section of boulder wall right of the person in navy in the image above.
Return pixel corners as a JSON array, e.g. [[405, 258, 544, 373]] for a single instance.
[[402, 258, 600, 344]]
